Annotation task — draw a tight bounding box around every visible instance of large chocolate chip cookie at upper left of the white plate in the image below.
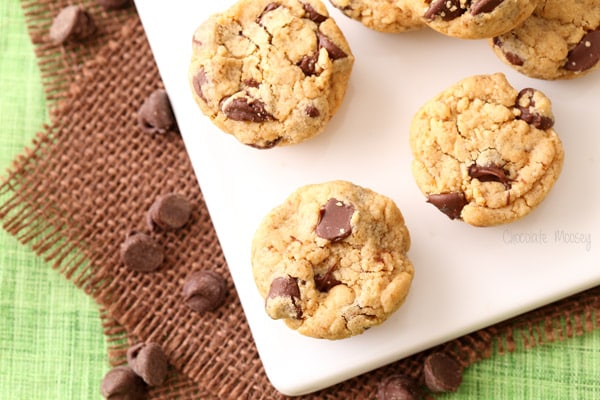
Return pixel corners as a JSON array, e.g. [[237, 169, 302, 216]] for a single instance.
[[189, 0, 354, 149]]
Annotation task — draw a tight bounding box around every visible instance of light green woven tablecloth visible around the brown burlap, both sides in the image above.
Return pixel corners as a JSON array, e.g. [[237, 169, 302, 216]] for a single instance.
[[0, 0, 600, 400]]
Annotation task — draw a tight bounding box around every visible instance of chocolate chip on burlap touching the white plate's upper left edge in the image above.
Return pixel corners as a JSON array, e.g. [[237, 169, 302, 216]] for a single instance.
[[138, 89, 175, 133]]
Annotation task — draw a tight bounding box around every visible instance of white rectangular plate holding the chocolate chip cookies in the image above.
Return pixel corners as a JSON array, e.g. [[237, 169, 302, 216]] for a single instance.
[[137, 0, 600, 395]]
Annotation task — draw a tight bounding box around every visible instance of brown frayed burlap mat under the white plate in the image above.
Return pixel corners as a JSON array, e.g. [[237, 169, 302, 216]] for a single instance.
[[0, 0, 600, 399]]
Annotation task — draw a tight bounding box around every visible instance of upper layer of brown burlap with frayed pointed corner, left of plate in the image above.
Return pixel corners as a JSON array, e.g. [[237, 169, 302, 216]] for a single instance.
[[0, 12, 284, 399]]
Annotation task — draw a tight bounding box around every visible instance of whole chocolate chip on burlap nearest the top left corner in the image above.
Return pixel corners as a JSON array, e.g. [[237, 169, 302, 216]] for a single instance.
[[49, 5, 96, 44]]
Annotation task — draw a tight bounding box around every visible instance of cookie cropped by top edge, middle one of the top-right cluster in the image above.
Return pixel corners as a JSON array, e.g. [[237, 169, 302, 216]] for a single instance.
[[413, 0, 539, 39]]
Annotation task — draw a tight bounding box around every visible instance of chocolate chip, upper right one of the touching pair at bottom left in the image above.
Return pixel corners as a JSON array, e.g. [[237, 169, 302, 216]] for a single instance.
[[127, 342, 169, 386]]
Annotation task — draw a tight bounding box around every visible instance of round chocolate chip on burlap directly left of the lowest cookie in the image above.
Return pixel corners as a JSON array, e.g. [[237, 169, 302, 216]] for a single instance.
[[182, 270, 227, 313]]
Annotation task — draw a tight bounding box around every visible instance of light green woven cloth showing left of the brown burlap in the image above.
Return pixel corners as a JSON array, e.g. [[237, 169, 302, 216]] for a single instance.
[[0, 0, 108, 400]]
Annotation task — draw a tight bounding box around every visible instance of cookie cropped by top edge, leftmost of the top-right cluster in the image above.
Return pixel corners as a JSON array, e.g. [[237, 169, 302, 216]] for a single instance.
[[329, 0, 425, 33]]
